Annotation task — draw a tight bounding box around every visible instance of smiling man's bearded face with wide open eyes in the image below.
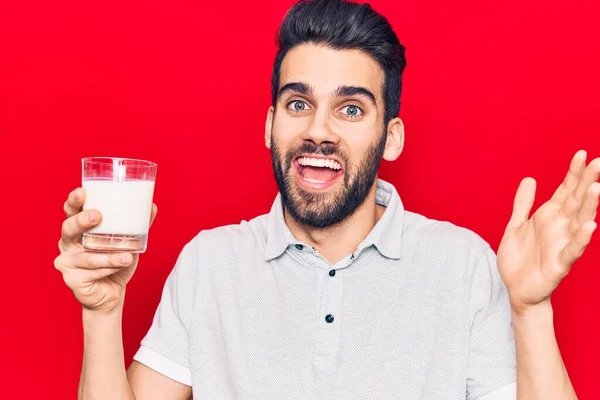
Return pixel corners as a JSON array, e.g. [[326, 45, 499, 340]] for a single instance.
[[267, 44, 386, 228]]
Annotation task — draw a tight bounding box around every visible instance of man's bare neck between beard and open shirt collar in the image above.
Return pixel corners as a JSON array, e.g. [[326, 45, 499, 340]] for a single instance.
[[284, 183, 385, 265]]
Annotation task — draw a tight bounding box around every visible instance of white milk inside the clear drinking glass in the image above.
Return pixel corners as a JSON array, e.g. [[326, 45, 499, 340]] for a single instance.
[[83, 179, 154, 236]]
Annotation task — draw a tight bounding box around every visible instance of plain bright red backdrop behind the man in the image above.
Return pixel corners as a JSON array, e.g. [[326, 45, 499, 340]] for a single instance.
[[0, 0, 600, 399]]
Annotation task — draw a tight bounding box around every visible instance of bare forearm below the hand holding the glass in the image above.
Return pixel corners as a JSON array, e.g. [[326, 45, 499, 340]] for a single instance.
[[79, 292, 135, 400]]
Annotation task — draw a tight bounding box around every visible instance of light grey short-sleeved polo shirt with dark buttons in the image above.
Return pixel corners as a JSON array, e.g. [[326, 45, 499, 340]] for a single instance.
[[134, 180, 516, 400]]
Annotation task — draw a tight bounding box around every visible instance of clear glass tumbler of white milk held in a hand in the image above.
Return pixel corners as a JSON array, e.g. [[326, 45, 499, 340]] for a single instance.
[[81, 157, 157, 253]]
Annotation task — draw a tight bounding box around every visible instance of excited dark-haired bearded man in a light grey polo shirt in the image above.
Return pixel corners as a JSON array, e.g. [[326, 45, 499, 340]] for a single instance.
[[55, 0, 600, 400]]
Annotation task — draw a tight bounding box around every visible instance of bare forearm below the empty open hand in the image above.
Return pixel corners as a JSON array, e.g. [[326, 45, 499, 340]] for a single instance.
[[512, 301, 577, 400]]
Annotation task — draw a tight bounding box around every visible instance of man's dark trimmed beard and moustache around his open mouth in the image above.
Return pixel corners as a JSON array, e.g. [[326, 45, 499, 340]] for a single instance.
[[271, 131, 387, 228]]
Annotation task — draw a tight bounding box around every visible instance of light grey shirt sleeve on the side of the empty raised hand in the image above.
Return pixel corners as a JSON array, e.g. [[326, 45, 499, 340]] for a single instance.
[[467, 248, 517, 400]]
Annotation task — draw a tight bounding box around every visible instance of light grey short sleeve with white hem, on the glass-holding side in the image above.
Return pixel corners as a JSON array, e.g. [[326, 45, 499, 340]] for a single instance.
[[133, 240, 197, 386]]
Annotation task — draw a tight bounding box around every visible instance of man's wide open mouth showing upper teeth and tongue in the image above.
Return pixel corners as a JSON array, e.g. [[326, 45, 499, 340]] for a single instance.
[[294, 156, 344, 190]]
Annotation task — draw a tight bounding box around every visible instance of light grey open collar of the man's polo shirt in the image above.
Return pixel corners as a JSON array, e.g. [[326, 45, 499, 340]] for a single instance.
[[265, 179, 404, 261]]
